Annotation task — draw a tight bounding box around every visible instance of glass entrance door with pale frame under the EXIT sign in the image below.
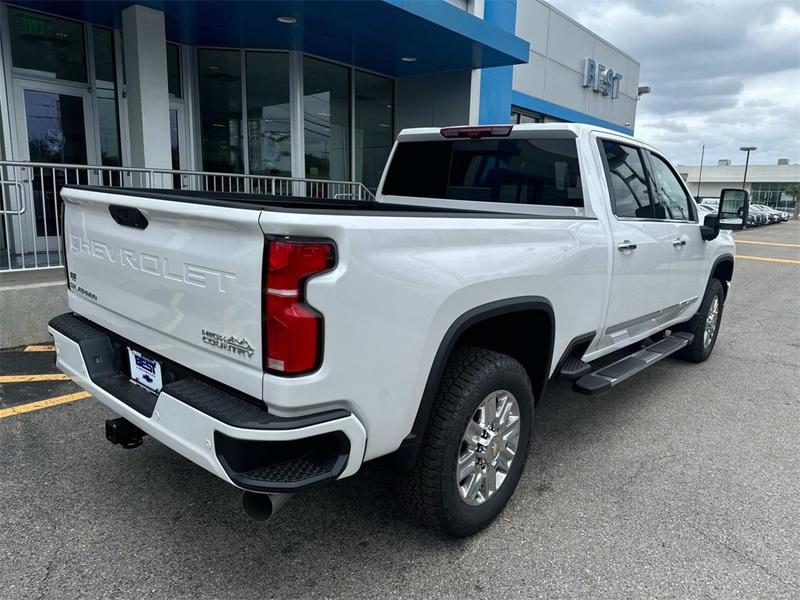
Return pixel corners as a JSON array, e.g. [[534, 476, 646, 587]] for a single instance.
[[14, 80, 97, 258]]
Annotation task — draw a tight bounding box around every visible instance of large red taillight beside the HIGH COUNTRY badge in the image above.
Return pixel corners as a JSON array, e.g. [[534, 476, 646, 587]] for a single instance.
[[263, 239, 335, 375]]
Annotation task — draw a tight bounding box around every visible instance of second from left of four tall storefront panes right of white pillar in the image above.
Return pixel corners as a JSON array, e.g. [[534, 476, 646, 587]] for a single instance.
[[247, 52, 292, 177]]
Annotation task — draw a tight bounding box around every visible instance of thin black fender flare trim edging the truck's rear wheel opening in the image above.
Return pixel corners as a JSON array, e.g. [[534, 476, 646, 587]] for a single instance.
[[394, 296, 556, 468]]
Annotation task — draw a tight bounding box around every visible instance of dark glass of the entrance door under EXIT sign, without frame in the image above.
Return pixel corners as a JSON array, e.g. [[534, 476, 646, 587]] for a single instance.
[[25, 90, 86, 236]]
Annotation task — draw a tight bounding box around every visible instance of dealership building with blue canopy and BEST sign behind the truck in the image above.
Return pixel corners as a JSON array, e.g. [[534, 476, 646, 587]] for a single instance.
[[0, 0, 639, 345]]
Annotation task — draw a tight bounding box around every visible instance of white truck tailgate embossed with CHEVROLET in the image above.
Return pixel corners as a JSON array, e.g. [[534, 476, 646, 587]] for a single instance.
[[62, 188, 264, 397]]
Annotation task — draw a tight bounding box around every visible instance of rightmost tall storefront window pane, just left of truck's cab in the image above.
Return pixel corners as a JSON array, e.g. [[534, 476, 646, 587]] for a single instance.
[[354, 71, 394, 189]]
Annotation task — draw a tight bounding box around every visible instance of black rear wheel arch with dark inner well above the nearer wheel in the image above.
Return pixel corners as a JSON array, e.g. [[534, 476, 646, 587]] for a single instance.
[[393, 296, 555, 469]]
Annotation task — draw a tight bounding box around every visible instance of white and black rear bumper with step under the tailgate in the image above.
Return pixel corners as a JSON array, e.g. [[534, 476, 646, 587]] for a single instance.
[[48, 314, 366, 493]]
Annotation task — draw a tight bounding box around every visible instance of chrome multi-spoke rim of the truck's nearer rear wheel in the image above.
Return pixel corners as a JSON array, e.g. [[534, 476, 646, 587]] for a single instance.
[[456, 390, 520, 506]]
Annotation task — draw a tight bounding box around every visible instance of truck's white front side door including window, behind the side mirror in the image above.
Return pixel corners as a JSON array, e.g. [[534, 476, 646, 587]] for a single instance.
[[647, 152, 712, 316]]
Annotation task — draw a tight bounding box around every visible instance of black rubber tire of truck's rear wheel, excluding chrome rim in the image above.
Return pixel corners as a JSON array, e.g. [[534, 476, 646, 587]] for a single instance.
[[402, 347, 534, 537]]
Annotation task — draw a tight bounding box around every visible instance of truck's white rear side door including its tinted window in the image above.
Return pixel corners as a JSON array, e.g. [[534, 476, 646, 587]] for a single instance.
[[599, 139, 673, 348]]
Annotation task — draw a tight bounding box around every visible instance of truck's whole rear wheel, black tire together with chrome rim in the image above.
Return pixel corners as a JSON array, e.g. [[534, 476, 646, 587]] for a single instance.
[[403, 347, 534, 537]]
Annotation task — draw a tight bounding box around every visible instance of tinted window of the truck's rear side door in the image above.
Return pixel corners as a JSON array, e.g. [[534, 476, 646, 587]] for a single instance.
[[603, 140, 663, 219]]
